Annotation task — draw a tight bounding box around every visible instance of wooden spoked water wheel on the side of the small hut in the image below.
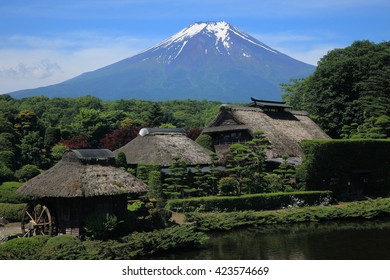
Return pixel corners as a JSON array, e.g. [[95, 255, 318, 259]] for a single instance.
[[22, 202, 55, 237]]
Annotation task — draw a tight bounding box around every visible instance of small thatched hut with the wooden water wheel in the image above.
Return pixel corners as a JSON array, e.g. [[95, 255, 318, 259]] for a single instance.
[[18, 149, 148, 236]]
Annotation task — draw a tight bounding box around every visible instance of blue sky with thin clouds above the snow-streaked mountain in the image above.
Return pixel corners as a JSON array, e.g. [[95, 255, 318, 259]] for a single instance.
[[0, 0, 390, 93]]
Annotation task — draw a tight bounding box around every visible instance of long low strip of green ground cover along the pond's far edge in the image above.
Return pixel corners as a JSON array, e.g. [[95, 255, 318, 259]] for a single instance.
[[186, 198, 390, 231]]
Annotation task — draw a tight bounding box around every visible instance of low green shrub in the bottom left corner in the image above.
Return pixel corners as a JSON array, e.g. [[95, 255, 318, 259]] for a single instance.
[[0, 236, 50, 260]]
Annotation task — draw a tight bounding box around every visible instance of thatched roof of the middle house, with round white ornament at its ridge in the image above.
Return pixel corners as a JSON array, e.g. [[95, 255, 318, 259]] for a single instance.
[[115, 128, 211, 167]]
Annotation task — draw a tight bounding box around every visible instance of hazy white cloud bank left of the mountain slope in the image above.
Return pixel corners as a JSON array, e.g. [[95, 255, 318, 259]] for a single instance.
[[0, 32, 156, 93]]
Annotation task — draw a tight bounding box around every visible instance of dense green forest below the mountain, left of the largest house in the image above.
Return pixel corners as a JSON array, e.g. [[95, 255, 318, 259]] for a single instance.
[[0, 95, 219, 181]]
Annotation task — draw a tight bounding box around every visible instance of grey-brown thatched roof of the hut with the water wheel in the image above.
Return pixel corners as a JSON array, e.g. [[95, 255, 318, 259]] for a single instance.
[[18, 150, 148, 198]]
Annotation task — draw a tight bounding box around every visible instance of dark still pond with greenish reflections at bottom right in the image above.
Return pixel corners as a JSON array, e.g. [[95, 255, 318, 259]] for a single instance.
[[155, 219, 390, 260]]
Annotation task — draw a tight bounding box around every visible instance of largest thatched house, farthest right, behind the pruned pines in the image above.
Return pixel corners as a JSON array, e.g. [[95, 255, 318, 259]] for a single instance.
[[203, 98, 330, 163]]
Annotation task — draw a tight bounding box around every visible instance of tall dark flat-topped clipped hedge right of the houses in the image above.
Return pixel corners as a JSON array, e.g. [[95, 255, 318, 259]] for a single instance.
[[299, 140, 390, 195]]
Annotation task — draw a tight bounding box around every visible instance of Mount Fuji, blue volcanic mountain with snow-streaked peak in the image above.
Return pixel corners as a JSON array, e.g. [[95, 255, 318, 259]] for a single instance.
[[10, 21, 315, 102]]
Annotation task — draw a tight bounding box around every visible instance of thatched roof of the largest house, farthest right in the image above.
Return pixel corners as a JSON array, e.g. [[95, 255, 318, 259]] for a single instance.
[[203, 104, 329, 158]]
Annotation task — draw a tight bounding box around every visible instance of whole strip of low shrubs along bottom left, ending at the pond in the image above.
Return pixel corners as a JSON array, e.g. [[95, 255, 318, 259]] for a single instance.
[[0, 226, 207, 260]]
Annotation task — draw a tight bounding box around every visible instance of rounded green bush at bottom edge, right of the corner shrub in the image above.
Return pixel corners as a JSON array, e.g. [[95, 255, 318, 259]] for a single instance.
[[37, 235, 86, 260]]
